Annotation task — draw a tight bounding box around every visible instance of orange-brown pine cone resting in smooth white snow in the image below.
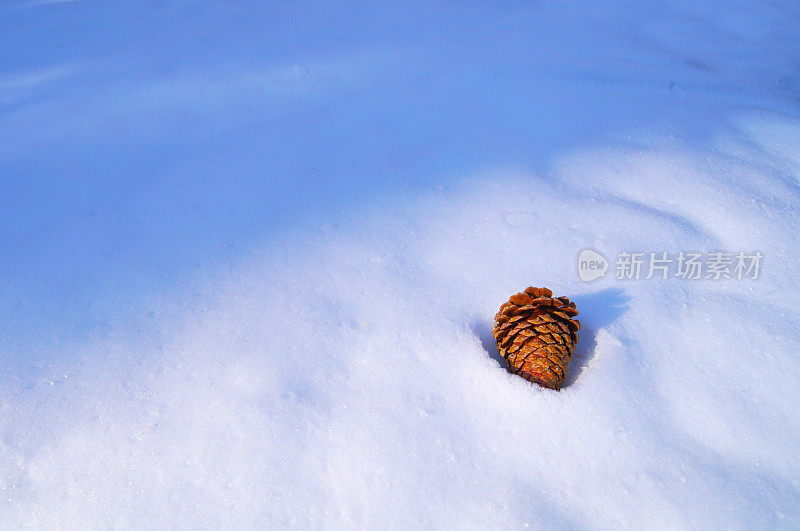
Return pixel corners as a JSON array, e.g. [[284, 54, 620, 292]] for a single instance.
[[492, 288, 581, 390]]
